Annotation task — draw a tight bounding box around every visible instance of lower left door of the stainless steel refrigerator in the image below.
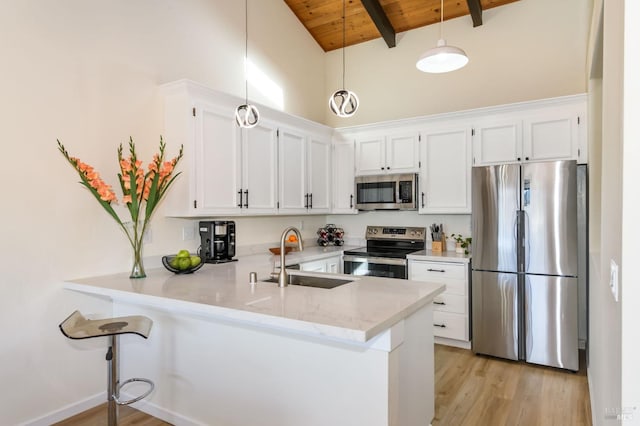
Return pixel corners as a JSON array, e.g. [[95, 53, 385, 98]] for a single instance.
[[471, 271, 518, 360]]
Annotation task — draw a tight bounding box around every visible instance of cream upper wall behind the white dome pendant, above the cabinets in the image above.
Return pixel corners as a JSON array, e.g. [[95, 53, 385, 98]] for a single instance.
[[325, 0, 592, 127]]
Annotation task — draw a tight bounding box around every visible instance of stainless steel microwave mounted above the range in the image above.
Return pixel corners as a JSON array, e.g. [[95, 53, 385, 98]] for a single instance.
[[355, 174, 418, 210]]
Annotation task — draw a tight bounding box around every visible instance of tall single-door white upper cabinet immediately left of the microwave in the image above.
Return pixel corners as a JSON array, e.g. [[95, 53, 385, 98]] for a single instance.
[[331, 140, 358, 214]]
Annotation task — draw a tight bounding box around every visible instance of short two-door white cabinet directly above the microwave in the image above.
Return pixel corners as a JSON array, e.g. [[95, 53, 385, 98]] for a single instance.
[[356, 132, 419, 176]]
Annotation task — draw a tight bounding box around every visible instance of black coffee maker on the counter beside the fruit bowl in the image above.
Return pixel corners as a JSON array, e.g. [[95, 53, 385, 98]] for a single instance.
[[198, 220, 237, 263]]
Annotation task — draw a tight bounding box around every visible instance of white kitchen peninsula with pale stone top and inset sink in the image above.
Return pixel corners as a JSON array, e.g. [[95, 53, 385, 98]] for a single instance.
[[64, 255, 444, 426]]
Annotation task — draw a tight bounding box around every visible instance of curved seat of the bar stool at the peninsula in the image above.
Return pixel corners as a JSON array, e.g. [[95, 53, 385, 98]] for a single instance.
[[60, 310, 153, 339]]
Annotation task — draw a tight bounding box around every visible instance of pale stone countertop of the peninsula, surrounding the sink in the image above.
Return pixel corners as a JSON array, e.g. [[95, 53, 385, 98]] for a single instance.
[[64, 247, 445, 343]]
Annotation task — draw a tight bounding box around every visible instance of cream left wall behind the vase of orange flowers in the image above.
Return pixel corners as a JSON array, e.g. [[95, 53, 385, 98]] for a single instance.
[[0, 0, 324, 425]]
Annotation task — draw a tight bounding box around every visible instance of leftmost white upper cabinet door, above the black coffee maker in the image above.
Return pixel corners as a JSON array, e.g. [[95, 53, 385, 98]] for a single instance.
[[194, 105, 241, 215]]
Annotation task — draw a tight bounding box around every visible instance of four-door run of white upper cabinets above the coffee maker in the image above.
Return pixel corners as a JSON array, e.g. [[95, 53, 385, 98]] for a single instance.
[[163, 80, 332, 217]]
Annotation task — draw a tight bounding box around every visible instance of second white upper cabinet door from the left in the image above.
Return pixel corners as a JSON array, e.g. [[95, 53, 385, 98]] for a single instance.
[[242, 120, 278, 214]]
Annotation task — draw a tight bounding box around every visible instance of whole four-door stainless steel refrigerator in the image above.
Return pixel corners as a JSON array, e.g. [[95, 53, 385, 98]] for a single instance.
[[471, 161, 579, 371]]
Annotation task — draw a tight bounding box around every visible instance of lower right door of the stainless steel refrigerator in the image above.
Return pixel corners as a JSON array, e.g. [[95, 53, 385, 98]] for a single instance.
[[524, 275, 578, 371]]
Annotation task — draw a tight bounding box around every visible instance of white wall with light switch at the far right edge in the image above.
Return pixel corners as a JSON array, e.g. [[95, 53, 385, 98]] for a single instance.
[[588, 0, 640, 425]]
